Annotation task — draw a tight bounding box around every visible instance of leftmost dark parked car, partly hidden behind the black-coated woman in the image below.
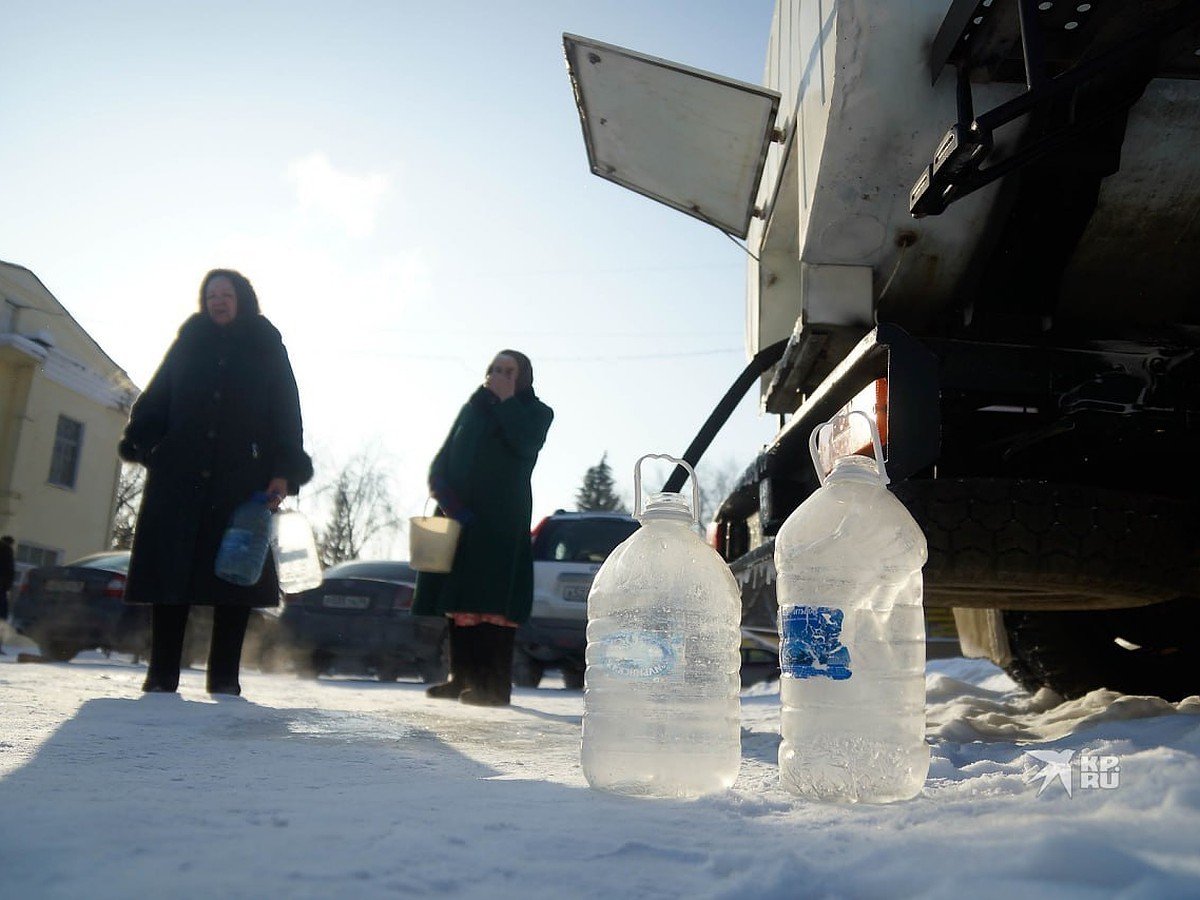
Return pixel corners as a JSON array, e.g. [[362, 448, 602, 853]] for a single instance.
[[8, 550, 277, 671]]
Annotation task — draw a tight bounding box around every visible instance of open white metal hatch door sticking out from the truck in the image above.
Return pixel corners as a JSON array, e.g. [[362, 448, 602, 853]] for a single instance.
[[563, 34, 780, 239]]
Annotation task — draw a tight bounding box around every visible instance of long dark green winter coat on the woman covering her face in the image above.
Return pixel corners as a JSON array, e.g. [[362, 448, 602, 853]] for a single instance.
[[413, 388, 554, 623]]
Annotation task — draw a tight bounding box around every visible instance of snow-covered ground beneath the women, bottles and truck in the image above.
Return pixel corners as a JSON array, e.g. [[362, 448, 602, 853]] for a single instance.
[[0, 644, 1200, 900]]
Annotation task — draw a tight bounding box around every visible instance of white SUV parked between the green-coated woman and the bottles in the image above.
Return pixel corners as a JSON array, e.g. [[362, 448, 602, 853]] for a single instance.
[[512, 510, 638, 690]]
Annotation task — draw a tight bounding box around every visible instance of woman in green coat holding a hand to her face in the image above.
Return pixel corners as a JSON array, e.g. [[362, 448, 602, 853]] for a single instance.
[[413, 350, 554, 707]]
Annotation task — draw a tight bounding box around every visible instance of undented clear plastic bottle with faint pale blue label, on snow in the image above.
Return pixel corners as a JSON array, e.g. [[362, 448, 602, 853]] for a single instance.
[[582, 456, 742, 798]]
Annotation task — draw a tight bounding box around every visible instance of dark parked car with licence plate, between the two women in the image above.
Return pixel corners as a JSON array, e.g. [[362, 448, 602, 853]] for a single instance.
[[280, 559, 449, 682]]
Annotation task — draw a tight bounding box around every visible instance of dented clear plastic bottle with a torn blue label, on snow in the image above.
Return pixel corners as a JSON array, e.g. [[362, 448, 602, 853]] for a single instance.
[[775, 414, 929, 803]]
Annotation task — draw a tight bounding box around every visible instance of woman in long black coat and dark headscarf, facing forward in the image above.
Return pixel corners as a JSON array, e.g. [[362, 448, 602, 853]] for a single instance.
[[118, 269, 312, 695]]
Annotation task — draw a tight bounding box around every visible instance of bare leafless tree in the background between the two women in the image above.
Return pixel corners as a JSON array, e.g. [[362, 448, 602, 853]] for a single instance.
[[317, 450, 402, 565]]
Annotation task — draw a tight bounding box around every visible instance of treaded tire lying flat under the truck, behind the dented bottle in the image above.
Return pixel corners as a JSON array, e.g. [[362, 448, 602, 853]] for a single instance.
[[893, 479, 1200, 613]]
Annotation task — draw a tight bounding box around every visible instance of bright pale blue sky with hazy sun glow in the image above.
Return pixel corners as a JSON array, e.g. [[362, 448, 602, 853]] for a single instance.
[[0, 0, 774, 553]]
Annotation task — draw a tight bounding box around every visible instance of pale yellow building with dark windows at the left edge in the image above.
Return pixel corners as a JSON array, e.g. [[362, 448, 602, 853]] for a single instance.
[[0, 256, 138, 569]]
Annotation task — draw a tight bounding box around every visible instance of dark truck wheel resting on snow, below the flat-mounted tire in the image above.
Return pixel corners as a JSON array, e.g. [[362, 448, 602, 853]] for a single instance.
[[1003, 598, 1200, 702]]
